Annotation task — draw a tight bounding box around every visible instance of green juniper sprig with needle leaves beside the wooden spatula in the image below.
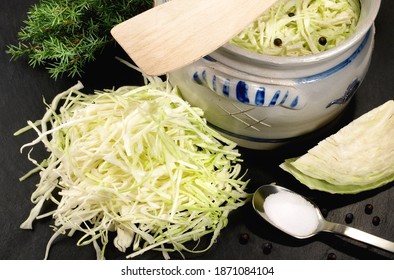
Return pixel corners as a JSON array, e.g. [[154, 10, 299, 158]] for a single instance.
[[7, 0, 153, 79]]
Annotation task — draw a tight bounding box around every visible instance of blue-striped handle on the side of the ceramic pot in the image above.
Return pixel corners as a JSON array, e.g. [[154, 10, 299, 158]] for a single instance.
[[190, 68, 305, 110]]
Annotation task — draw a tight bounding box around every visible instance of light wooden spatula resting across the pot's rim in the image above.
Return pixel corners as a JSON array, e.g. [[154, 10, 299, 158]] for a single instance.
[[111, 0, 278, 75]]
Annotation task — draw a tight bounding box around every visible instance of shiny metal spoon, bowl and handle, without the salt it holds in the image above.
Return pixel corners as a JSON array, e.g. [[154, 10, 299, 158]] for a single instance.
[[252, 184, 394, 253]]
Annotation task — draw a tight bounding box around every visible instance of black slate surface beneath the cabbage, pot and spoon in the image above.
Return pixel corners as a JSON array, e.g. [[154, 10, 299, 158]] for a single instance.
[[0, 0, 394, 260]]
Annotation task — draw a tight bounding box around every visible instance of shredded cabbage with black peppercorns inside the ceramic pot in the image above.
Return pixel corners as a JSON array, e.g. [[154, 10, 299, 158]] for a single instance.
[[230, 0, 361, 56]]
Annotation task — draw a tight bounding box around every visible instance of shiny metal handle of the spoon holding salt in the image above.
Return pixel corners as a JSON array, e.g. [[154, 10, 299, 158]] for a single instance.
[[322, 222, 394, 253]]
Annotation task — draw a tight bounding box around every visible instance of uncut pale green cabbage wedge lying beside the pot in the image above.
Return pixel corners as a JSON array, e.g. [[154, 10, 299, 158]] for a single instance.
[[280, 100, 394, 194]]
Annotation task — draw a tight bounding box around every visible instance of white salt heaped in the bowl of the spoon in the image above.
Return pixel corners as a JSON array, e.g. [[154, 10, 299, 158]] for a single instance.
[[264, 191, 319, 236]]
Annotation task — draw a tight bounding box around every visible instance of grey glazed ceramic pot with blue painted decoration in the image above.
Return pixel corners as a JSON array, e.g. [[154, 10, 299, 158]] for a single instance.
[[156, 0, 381, 149]]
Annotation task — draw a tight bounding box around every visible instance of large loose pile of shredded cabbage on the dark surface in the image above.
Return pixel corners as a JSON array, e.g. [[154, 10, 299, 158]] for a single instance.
[[15, 79, 249, 259]]
